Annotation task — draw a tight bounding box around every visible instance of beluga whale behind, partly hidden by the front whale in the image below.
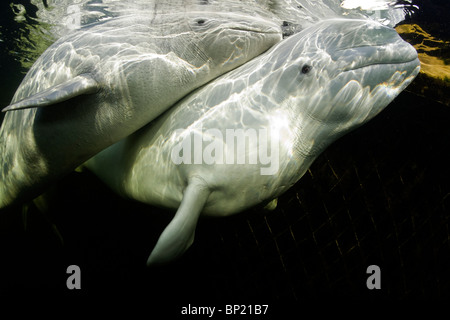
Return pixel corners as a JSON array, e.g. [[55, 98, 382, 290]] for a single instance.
[[0, 11, 282, 208]]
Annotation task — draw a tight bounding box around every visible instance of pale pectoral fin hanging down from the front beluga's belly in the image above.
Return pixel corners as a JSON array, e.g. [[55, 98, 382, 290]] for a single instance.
[[147, 179, 211, 266]]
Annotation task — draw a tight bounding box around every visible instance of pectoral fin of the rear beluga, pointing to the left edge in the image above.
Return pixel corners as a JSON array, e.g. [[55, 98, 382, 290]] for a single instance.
[[2, 74, 100, 112]]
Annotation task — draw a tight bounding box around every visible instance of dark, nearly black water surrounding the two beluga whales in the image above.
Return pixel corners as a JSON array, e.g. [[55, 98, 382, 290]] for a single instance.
[[0, 1, 450, 311]]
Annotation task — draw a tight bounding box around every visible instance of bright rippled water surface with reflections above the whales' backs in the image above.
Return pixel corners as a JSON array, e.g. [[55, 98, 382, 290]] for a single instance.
[[0, 0, 416, 70]]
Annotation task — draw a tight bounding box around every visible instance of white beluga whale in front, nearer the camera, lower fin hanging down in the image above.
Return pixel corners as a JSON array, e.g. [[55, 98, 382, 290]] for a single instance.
[[85, 19, 420, 265]]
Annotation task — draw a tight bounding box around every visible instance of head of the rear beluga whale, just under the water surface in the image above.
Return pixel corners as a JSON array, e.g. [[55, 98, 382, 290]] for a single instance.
[[186, 12, 282, 70]]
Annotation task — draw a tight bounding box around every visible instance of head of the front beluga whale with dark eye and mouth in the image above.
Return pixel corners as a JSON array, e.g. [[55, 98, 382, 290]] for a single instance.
[[263, 19, 420, 156]]
